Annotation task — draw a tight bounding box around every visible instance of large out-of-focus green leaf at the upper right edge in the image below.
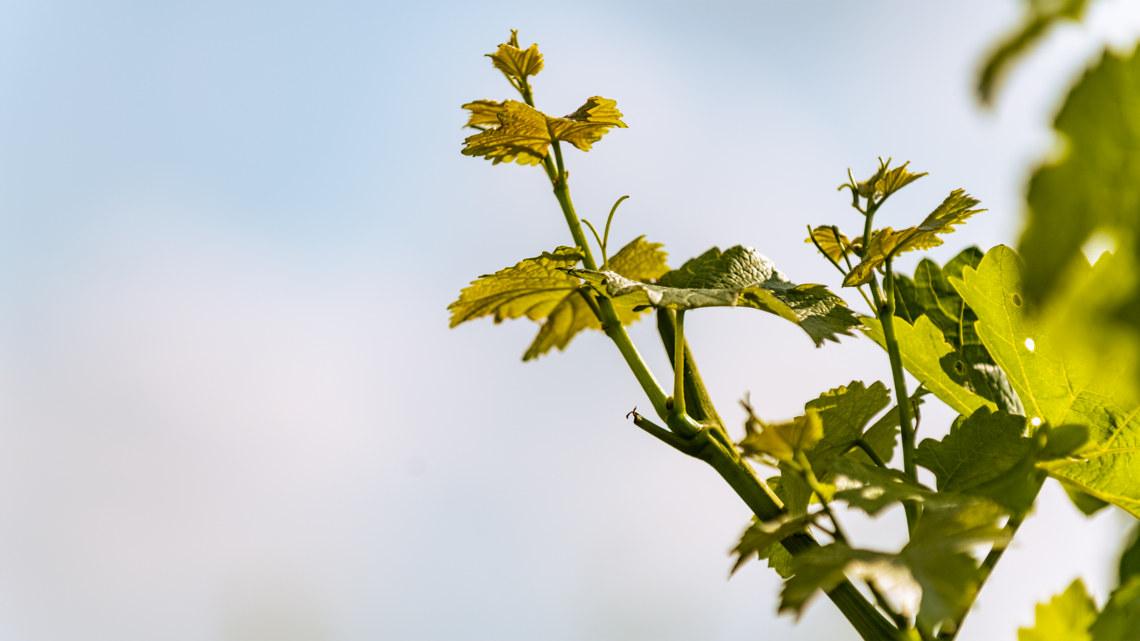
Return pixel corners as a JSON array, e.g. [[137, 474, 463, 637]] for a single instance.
[[1018, 51, 1140, 300]]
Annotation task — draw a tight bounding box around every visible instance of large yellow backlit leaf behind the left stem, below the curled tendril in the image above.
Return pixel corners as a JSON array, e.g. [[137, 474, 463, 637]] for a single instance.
[[448, 236, 669, 360]]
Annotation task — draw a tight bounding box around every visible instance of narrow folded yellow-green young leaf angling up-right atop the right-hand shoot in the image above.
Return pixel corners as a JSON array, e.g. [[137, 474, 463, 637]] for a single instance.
[[844, 189, 986, 287]]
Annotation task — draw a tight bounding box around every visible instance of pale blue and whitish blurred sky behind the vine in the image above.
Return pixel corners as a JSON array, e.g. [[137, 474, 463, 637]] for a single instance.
[[0, 0, 1140, 641]]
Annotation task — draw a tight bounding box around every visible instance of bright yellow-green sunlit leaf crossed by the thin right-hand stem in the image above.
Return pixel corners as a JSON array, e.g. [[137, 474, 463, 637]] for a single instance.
[[862, 315, 998, 416]]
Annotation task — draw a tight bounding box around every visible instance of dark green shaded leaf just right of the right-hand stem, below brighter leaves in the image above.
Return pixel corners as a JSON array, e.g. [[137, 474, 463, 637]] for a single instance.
[[915, 407, 1044, 512]]
